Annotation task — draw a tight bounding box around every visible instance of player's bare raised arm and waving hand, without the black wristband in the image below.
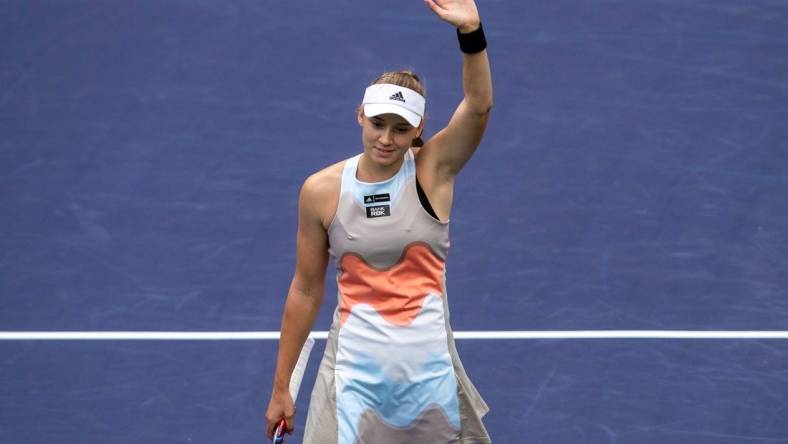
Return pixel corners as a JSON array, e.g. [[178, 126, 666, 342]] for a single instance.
[[422, 0, 493, 182]]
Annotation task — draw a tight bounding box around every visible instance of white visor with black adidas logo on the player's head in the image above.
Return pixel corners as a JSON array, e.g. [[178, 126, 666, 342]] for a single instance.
[[362, 83, 424, 127]]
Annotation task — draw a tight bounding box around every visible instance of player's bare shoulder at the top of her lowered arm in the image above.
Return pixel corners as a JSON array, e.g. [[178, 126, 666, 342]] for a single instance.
[[300, 160, 345, 229]]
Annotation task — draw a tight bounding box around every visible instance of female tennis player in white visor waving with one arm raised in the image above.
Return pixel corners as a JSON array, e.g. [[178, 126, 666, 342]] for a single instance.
[[266, 0, 493, 444]]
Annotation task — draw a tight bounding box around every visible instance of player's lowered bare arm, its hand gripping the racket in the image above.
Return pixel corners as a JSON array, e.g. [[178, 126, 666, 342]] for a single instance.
[[266, 176, 328, 438]]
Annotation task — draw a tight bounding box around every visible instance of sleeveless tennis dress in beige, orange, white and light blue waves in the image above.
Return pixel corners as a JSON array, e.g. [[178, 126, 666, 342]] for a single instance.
[[304, 150, 491, 444]]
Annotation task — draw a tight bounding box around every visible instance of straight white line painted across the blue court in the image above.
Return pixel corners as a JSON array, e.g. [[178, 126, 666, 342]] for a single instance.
[[0, 330, 788, 341]]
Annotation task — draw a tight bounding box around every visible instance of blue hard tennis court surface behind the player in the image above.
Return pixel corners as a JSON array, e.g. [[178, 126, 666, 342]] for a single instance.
[[0, 0, 788, 444]]
